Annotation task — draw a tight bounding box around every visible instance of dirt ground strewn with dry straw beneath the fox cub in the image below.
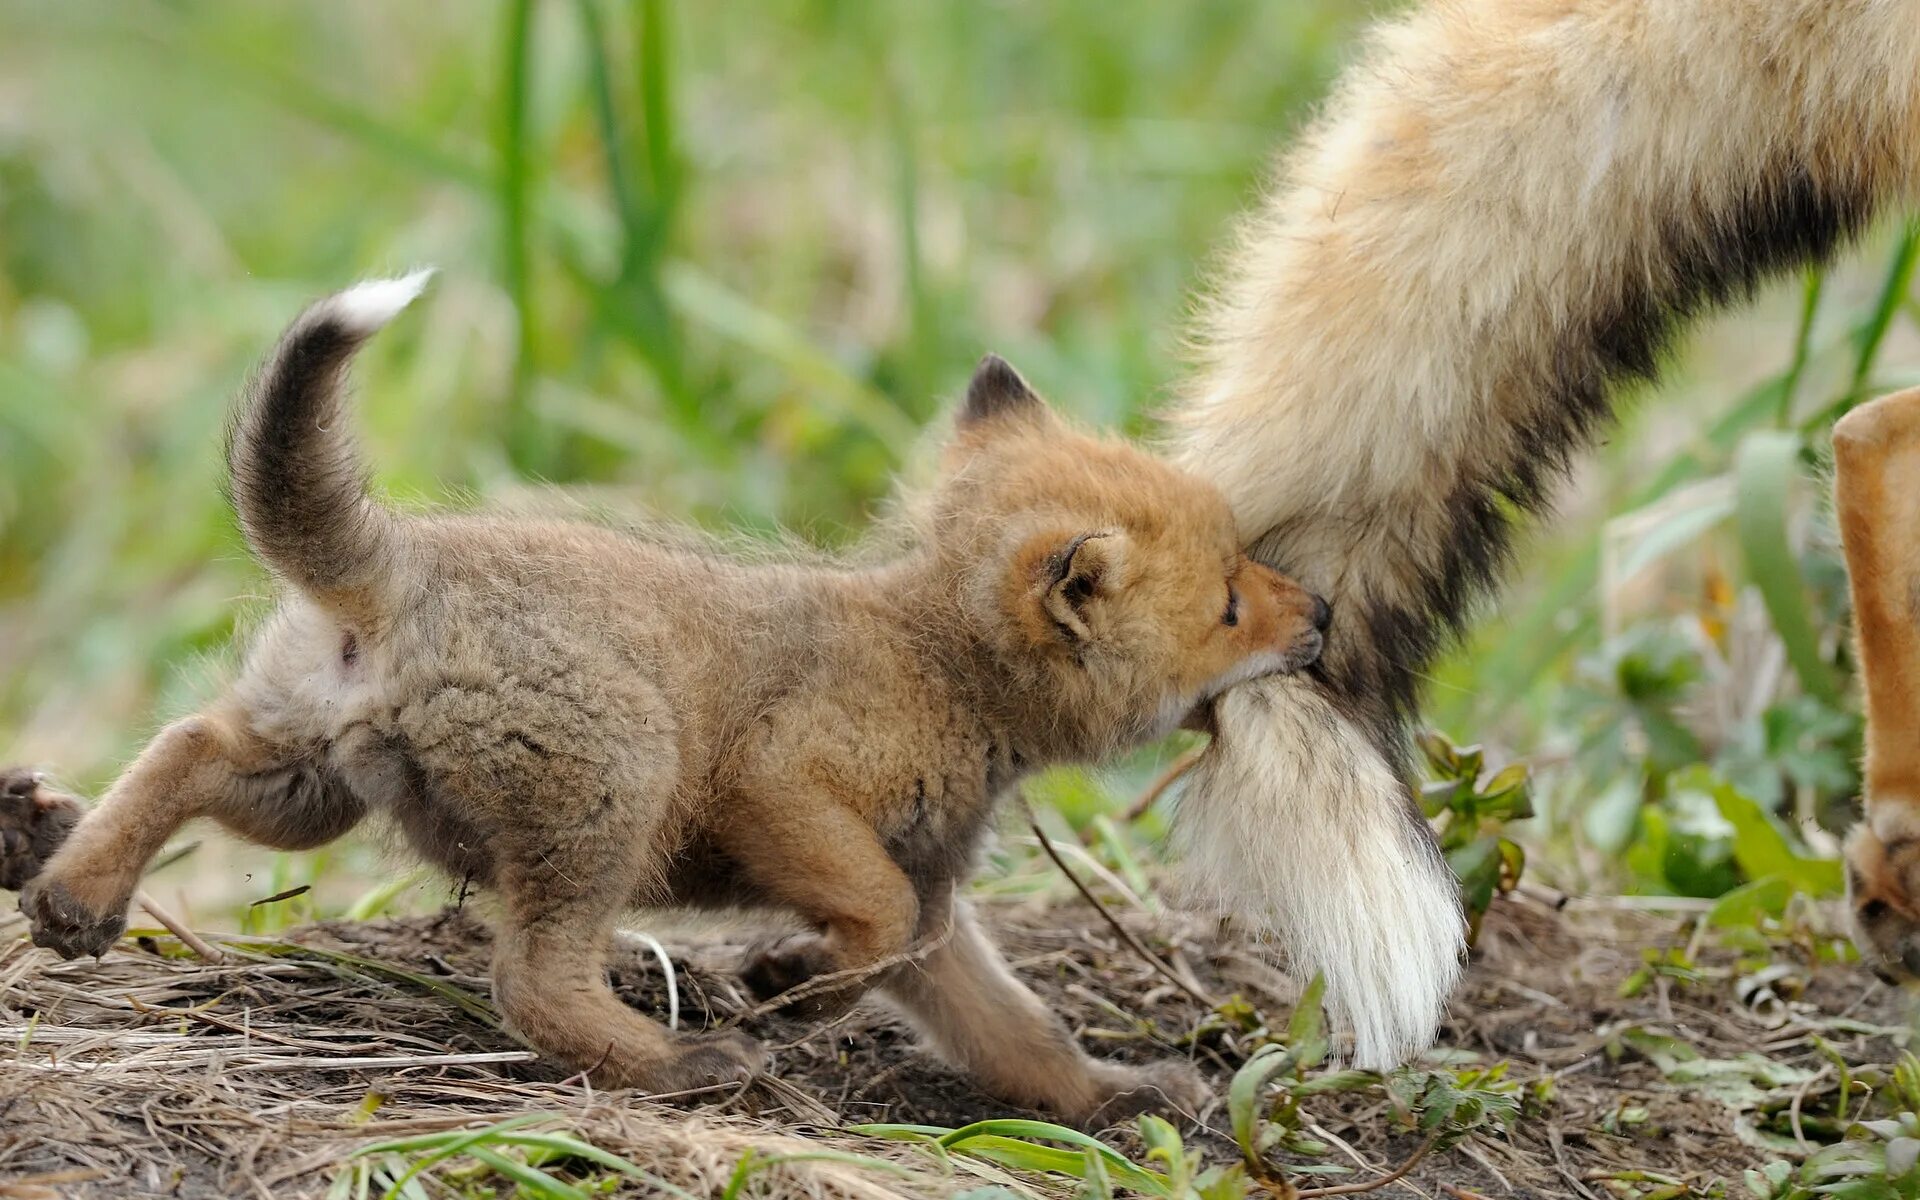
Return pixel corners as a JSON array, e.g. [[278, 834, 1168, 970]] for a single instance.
[[0, 897, 1910, 1198]]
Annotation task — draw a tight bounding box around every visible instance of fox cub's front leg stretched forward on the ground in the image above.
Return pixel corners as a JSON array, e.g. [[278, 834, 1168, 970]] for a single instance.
[[885, 897, 1208, 1127]]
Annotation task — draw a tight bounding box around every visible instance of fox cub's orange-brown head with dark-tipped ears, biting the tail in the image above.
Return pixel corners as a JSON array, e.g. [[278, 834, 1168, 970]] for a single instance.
[[927, 355, 1329, 745]]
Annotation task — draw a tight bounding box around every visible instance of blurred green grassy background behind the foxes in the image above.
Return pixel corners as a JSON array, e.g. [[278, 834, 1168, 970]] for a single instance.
[[0, 0, 1920, 916]]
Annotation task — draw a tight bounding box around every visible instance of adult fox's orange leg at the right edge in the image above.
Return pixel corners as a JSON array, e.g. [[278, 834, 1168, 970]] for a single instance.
[[1834, 388, 1920, 979]]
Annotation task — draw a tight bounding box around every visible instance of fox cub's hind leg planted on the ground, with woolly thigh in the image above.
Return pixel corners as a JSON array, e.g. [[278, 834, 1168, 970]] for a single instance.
[[412, 679, 760, 1092]]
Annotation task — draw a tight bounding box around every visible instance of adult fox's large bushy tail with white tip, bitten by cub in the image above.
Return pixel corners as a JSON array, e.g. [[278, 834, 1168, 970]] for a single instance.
[[1169, 0, 1920, 1062]]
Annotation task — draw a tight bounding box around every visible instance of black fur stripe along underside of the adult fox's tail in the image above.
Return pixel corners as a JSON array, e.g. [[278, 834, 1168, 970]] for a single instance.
[[1313, 167, 1874, 766]]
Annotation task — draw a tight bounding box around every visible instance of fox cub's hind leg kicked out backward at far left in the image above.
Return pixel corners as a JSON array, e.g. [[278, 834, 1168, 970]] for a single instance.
[[19, 708, 363, 958]]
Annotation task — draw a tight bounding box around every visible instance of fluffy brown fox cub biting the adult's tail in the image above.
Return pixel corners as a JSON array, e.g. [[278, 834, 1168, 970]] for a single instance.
[[21, 275, 1329, 1119]]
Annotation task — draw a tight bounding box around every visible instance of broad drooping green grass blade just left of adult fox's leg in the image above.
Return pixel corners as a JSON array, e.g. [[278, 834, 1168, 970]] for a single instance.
[[1734, 430, 1841, 703]]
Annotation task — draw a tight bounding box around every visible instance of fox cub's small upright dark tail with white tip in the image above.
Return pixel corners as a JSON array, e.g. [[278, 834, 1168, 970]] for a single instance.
[[227, 271, 432, 614]]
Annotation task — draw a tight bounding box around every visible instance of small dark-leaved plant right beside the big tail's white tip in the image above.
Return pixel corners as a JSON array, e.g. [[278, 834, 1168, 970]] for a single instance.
[[1421, 733, 1534, 943]]
